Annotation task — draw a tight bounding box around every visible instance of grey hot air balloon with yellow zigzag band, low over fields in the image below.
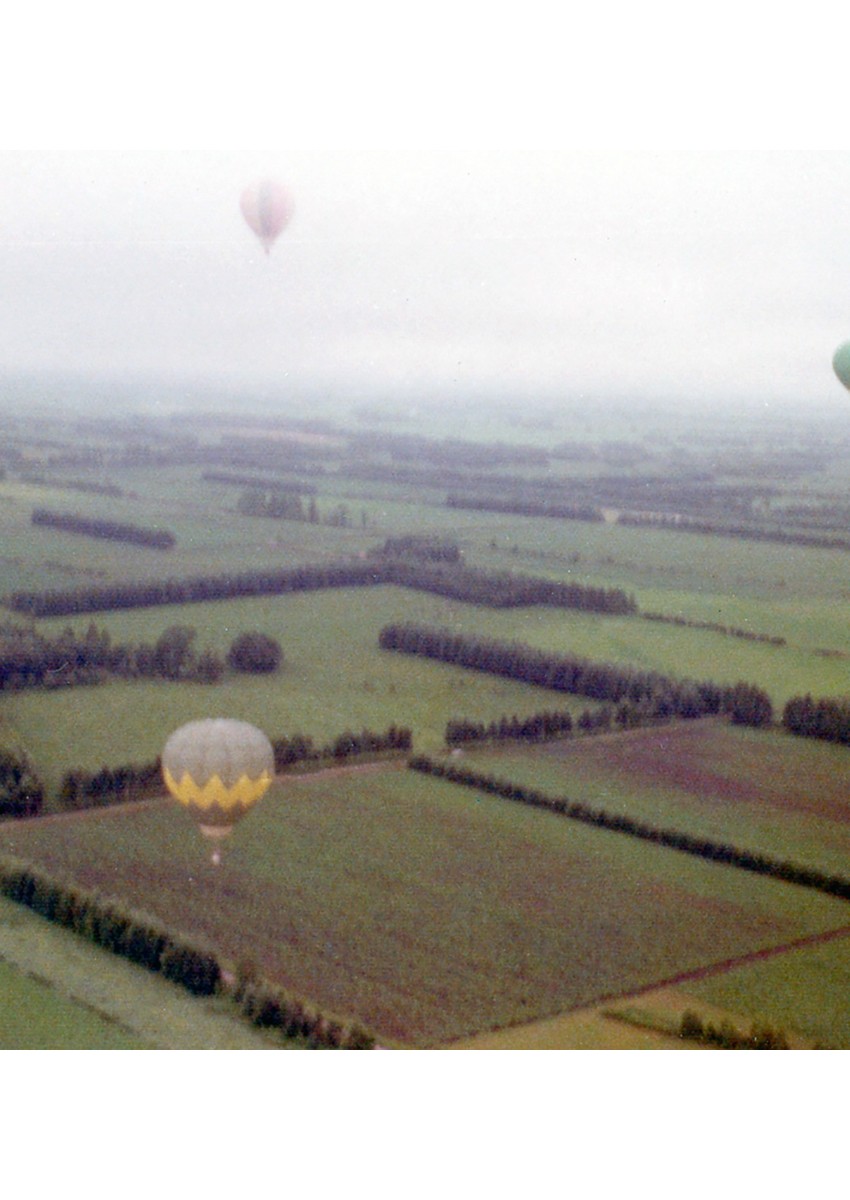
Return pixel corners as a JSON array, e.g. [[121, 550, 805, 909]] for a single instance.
[[162, 719, 275, 866]]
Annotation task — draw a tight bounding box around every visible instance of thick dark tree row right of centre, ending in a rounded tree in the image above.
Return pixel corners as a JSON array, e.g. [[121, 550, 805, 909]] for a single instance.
[[378, 624, 773, 726]]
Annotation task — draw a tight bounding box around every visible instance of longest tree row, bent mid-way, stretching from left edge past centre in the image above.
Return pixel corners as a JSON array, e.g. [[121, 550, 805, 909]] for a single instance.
[[7, 558, 638, 617]]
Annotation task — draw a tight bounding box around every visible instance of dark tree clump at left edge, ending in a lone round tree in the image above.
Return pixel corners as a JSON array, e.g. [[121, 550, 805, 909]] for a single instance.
[[0, 623, 282, 691]]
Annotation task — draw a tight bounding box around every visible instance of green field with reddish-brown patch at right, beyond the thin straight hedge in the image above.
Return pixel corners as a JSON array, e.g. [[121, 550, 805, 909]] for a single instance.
[[463, 720, 850, 875]]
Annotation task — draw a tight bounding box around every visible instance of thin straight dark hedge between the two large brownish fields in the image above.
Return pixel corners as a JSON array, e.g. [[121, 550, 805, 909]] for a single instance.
[[407, 755, 850, 900]]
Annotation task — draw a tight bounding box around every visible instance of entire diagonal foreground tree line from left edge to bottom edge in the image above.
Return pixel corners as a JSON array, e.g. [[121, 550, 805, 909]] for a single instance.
[[0, 859, 375, 1050]]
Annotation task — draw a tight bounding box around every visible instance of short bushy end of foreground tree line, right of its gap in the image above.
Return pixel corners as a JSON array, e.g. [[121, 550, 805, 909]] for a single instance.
[[234, 964, 375, 1050]]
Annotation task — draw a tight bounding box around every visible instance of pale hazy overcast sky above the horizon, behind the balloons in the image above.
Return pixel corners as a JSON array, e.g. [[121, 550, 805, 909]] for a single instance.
[[0, 149, 850, 422]]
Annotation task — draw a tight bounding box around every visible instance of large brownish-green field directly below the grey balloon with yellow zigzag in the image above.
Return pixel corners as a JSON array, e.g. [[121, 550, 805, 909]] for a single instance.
[[0, 768, 849, 1045]]
